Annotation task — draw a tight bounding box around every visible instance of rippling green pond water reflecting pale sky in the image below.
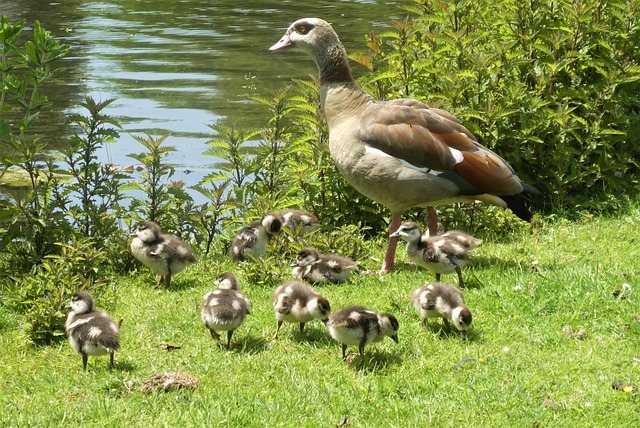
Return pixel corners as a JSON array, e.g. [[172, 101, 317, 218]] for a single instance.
[[0, 0, 407, 192]]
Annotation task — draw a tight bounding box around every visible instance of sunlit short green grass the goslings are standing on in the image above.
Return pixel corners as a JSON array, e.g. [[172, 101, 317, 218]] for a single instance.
[[0, 210, 640, 427]]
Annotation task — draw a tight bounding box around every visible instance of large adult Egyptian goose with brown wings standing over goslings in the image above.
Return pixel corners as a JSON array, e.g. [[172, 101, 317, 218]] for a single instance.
[[269, 18, 537, 272]]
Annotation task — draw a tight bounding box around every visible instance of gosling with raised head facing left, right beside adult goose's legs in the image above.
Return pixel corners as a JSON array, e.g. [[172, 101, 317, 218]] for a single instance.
[[391, 222, 482, 288]]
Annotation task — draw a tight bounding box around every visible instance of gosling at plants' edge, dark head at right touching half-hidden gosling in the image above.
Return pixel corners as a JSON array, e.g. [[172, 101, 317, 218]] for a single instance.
[[229, 214, 282, 262]]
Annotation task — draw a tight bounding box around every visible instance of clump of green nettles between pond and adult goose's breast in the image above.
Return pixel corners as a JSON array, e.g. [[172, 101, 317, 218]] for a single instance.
[[200, 81, 386, 239]]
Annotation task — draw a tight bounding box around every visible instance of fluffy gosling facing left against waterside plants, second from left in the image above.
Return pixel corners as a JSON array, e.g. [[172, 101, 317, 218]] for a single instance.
[[131, 221, 196, 287]]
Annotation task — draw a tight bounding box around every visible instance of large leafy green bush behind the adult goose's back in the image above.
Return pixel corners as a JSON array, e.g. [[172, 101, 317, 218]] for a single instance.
[[353, 0, 640, 211]]
